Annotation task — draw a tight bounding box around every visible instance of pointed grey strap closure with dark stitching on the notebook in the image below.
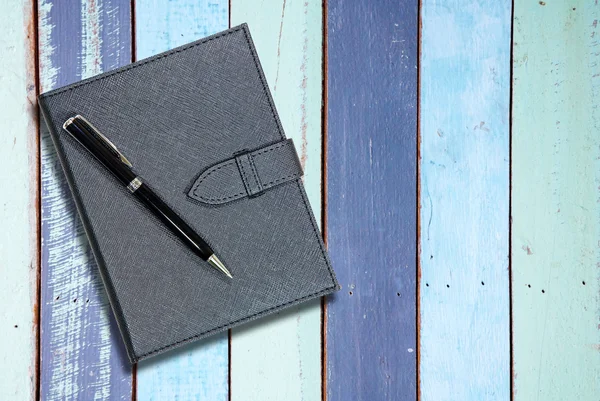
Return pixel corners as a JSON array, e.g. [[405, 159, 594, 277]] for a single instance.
[[188, 139, 302, 205]]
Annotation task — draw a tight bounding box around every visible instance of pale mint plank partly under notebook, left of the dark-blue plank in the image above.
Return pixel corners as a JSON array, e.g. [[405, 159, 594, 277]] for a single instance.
[[231, 0, 323, 401]]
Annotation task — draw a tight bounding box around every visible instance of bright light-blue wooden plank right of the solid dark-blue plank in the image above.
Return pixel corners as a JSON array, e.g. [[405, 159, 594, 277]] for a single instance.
[[419, 0, 511, 401]]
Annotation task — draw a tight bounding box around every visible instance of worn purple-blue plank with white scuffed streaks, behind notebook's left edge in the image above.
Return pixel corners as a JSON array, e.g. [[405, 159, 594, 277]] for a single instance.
[[38, 0, 131, 400]]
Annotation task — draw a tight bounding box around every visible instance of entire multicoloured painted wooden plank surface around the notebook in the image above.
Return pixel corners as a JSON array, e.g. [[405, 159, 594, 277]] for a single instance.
[[0, 0, 600, 401]]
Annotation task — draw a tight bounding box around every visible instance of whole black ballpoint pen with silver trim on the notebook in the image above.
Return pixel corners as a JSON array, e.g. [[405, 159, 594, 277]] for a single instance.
[[63, 115, 232, 278]]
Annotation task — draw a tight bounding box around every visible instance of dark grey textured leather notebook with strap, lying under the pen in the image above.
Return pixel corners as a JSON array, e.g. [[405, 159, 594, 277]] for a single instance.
[[39, 25, 339, 363]]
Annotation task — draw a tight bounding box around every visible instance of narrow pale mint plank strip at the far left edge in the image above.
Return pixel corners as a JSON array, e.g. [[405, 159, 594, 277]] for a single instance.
[[0, 0, 39, 400]]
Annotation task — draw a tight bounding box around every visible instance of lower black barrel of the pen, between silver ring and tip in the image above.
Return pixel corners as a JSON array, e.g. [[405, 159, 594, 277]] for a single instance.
[[133, 183, 213, 260]]
